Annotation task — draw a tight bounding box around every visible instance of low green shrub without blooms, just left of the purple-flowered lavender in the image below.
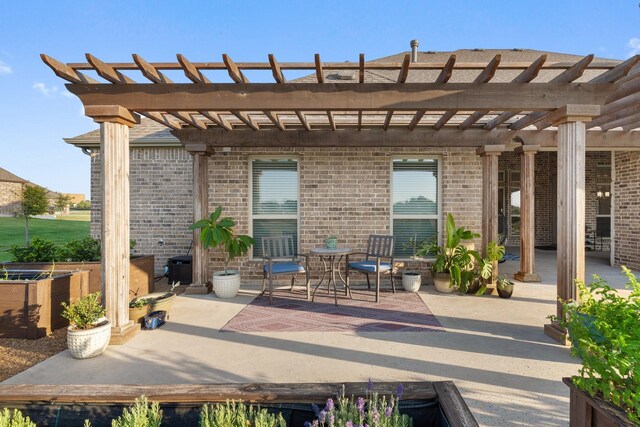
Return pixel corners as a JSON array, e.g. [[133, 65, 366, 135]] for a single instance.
[[200, 401, 287, 427]]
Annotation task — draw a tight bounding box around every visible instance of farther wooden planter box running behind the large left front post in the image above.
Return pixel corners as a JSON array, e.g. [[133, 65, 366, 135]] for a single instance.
[[2, 255, 154, 300]]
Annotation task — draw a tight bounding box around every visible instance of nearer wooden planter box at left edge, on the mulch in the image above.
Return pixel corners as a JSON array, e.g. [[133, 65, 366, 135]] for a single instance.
[[0, 270, 89, 339]]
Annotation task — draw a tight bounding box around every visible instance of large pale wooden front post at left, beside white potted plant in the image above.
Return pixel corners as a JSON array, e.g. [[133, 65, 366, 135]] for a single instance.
[[85, 106, 140, 344]]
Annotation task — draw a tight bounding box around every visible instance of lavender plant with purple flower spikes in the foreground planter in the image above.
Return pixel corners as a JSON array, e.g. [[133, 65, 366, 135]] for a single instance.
[[305, 380, 413, 427]]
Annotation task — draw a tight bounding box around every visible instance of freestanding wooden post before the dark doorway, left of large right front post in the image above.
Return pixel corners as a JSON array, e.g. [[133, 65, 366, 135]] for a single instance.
[[514, 145, 540, 282]]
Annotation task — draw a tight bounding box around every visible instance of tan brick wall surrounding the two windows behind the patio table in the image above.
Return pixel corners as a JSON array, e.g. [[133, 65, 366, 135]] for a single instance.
[[204, 148, 482, 280]]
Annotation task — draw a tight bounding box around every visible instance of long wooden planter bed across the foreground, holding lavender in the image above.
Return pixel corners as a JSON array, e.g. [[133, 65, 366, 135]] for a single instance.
[[0, 381, 478, 427]]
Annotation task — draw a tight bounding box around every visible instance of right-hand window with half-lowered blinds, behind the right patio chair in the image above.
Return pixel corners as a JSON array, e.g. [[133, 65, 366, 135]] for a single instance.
[[391, 158, 440, 258]]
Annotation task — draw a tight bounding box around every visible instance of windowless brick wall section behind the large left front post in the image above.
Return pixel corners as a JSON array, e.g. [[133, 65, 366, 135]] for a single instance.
[[91, 148, 193, 275]]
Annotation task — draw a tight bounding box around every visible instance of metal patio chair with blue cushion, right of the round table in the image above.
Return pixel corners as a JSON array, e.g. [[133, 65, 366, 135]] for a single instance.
[[345, 234, 396, 302]]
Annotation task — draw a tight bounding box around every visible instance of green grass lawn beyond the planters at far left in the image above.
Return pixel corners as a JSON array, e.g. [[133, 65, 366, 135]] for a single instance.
[[0, 217, 90, 261]]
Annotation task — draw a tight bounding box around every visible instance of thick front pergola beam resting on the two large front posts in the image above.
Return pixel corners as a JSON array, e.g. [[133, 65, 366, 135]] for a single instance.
[[67, 83, 616, 111]]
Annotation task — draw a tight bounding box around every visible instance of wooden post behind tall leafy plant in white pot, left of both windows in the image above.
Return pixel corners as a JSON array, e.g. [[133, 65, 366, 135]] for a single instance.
[[185, 144, 211, 294]]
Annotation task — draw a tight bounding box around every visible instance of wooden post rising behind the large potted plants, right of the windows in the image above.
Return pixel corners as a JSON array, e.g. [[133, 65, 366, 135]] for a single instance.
[[477, 144, 505, 281]]
